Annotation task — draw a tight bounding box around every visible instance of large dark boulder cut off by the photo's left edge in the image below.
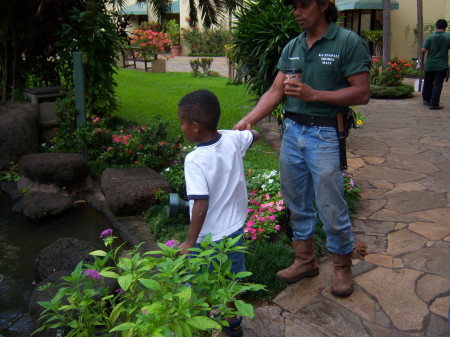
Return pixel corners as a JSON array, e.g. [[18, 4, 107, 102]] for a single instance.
[[0, 102, 39, 169]]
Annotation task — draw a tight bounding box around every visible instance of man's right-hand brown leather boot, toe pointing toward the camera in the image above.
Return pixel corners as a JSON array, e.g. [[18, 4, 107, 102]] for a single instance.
[[331, 253, 353, 297]]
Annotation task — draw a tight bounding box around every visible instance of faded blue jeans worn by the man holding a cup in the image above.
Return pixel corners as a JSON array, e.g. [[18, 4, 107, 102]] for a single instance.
[[280, 118, 354, 254]]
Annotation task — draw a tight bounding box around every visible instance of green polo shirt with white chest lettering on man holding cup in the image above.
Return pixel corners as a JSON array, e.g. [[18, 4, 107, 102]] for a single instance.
[[277, 23, 371, 117]]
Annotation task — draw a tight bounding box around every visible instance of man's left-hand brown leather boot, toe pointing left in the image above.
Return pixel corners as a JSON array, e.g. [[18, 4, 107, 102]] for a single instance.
[[277, 238, 319, 283]]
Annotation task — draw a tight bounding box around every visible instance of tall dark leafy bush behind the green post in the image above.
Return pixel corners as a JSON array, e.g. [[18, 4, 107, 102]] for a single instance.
[[58, 0, 121, 117]]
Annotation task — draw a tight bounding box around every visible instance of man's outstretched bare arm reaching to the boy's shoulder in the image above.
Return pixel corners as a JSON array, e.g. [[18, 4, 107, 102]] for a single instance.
[[233, 71, 284, 130]]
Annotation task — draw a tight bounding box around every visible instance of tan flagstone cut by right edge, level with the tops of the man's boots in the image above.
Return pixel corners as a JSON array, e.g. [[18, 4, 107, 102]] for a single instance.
[[403, 246, 450, 278]]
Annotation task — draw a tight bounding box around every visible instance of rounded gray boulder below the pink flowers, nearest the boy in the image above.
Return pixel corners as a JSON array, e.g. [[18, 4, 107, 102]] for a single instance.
[[101, 168, 170, 215]]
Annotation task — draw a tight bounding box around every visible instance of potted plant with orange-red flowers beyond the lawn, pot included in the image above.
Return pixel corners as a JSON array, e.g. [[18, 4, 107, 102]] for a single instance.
[[130, 29, 170, 73]]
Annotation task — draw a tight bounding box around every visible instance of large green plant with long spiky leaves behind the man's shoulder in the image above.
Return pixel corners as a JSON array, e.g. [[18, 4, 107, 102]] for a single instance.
[[233, 0, 301, 97]]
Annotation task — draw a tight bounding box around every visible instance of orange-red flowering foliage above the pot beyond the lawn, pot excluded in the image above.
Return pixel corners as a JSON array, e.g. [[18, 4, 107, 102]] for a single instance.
[[130, 29, 171, 60]]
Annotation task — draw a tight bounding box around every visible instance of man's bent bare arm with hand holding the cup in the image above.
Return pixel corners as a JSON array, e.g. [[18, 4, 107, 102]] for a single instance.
[[285, 72, 370, 106]]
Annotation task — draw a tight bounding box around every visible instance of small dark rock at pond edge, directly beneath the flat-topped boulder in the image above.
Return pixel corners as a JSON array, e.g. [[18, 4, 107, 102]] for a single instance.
[[21, 192, 73, 220]]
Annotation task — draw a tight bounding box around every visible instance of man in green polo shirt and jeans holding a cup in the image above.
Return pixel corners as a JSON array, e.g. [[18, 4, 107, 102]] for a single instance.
[[234, 0, 371, 296]]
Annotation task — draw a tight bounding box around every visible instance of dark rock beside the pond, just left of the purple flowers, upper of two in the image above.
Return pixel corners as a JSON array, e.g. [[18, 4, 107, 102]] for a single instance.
[[35, 238, 103, 280]]
